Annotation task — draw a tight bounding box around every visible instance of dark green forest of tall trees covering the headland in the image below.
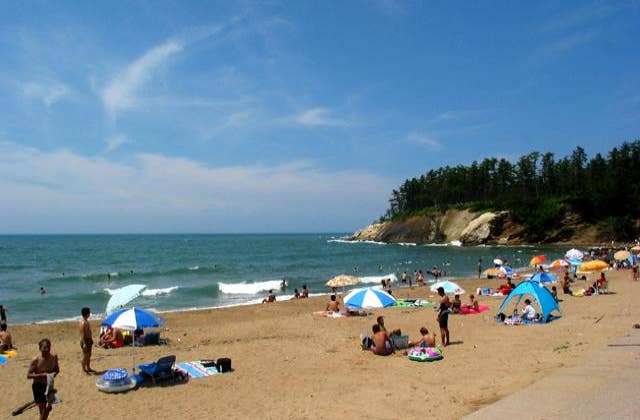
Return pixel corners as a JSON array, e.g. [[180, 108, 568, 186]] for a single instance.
[[381, 140, 640, 239]]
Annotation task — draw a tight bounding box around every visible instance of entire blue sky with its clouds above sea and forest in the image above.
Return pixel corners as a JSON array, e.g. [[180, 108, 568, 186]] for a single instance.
[[0, 0, 640, 233]]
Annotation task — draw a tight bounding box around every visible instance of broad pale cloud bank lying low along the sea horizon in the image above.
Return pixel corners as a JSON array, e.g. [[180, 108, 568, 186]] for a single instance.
[[0, 142, 397, 233]]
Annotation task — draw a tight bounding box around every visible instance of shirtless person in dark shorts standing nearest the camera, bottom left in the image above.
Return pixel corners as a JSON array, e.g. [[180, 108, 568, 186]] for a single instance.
[[27, 338, 60, 420]]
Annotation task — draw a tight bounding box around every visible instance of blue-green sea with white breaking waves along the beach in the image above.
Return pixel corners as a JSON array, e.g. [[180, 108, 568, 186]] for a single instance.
[[0, 233, 565, 324]]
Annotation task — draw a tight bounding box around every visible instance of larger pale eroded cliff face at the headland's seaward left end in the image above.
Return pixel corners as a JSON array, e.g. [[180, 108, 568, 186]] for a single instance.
[[350, 210, 522, 245]]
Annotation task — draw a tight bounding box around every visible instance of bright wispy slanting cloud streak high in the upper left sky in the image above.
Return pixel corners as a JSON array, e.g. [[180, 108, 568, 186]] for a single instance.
[[101, 40, 183, 116]]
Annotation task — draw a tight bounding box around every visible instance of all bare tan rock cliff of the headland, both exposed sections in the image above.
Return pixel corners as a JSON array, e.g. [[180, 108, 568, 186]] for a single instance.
[[349, 209, 602, 245]]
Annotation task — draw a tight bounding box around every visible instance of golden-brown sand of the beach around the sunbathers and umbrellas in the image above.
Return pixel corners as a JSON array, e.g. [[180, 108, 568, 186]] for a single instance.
[[0, 271, 640, 419]]
